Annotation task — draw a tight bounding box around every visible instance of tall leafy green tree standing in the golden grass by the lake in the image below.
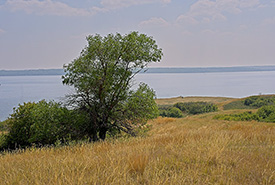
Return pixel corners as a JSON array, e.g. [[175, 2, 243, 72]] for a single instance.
[[62, 32, 163, 141]]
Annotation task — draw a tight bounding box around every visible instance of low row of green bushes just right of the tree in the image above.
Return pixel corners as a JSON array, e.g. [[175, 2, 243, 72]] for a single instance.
[[159, 102, 218, 118]]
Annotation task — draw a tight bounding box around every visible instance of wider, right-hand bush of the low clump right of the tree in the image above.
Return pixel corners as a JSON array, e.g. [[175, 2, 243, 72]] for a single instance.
[[174, 102, 218, 114]]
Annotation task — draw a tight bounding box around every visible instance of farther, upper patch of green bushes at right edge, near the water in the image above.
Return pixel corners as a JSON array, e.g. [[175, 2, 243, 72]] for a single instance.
[[224, 95, 275, 110]]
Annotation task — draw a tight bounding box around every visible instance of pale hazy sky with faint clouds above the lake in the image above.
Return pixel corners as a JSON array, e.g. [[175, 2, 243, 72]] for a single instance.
[[0, 0, 275, 70]]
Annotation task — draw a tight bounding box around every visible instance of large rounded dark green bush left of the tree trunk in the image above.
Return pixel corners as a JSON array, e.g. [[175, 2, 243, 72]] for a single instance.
[[2, 100, 87, 149]]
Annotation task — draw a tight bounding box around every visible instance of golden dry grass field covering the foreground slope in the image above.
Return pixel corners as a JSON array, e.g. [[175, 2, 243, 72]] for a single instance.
[[0, 97, 275, 185]]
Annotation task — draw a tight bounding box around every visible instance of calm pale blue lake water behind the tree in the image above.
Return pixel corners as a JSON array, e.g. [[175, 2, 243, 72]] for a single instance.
[[0, 71, 275, 120]]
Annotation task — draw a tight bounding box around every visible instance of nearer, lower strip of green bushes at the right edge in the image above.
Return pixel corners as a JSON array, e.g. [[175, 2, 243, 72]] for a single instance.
[[214, 105, 275, 123]]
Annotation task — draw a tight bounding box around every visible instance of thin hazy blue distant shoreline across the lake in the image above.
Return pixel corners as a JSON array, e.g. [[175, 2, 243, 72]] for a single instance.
[[0, 65, 275, 76]]
